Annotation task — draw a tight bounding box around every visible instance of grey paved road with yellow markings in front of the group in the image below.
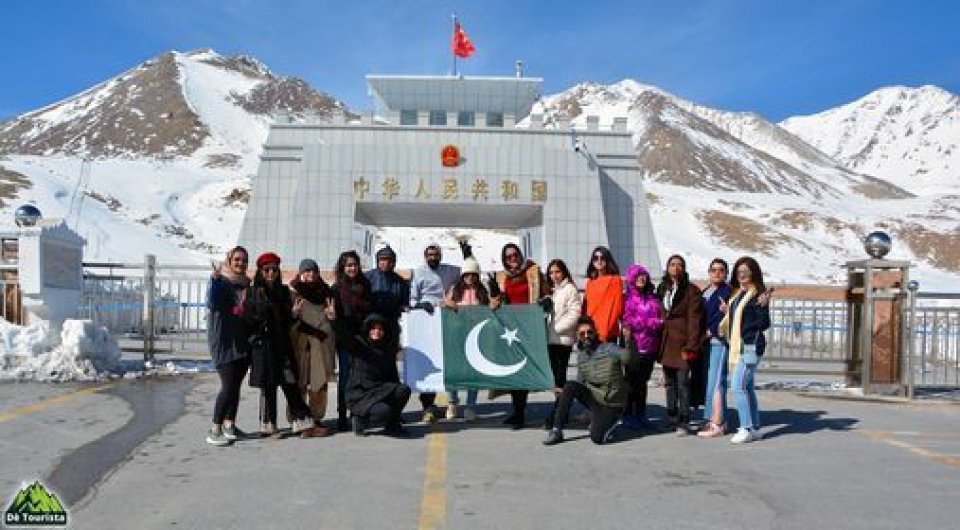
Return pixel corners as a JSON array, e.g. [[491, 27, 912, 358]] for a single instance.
[[0, 374, 960, 529]]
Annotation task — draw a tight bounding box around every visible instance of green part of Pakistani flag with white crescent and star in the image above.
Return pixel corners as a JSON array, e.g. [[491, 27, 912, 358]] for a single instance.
[[442, 304, 553, 390]]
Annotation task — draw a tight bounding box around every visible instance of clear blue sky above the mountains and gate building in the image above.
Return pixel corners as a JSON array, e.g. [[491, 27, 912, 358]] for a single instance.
[[0, 0, 960, 120]]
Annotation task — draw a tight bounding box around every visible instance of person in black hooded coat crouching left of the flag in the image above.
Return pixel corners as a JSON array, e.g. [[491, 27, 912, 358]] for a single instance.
[[347, 313, 410, 436]]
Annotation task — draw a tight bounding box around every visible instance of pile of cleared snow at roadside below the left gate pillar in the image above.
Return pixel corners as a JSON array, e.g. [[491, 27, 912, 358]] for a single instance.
[[0, 319, 120, 381]]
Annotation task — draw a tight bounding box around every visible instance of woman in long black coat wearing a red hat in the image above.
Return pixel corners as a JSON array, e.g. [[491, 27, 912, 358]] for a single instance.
[[244, 252, 314, 437]]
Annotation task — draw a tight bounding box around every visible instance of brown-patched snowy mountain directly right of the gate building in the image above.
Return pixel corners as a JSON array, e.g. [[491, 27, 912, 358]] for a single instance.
[[534, 80, 960, 289]]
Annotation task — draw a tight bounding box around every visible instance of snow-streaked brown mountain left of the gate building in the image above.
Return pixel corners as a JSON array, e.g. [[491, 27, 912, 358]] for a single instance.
[[0, 50, 353, 262]]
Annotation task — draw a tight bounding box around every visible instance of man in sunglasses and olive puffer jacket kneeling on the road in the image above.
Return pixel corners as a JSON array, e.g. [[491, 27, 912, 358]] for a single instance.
[[543, 316, 633, 445]]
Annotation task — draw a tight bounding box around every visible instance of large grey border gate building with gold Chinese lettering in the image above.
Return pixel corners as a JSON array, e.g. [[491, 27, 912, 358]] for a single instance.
[[240, 75, 660, 274]]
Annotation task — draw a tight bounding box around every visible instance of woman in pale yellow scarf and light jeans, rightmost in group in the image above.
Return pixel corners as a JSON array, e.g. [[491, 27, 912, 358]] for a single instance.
[[719, 256, 771, 444]]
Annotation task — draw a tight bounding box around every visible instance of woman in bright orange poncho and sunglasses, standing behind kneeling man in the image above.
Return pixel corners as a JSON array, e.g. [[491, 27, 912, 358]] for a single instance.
[[582, 247, 623, 342]]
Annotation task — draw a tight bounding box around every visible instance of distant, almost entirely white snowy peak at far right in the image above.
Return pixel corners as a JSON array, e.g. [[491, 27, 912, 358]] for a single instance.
[[780, 86, 960, 193]]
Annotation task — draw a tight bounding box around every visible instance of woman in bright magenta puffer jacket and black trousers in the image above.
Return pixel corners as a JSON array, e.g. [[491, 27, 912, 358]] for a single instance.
[[623, 264, 663, 429]]
